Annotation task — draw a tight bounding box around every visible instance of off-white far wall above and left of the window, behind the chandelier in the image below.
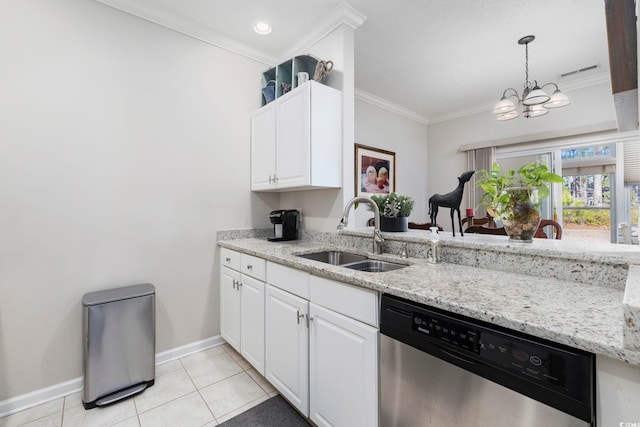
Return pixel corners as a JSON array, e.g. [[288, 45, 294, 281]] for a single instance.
[[427, 83, 616, 230]]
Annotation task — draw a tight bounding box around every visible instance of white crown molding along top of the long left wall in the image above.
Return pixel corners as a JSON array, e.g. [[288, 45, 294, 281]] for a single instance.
[[96, 0, 277, 66]]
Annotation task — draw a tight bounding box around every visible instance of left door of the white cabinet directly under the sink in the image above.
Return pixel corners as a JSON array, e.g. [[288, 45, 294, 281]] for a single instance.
[[265, 285, 309, 415]]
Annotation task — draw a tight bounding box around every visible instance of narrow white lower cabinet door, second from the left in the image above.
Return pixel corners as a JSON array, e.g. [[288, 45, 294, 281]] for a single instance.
[[240, 274, 265, 375]]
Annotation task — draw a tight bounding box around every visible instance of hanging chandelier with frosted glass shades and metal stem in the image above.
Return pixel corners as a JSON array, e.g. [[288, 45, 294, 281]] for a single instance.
[[493, 36, 571, 121]]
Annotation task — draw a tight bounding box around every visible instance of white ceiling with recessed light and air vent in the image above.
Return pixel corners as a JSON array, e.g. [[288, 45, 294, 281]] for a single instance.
[[98, 0, 609, 122]]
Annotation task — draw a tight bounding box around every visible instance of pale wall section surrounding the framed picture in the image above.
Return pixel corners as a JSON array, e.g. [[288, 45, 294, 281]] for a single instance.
[[349, 100, 428, 228]]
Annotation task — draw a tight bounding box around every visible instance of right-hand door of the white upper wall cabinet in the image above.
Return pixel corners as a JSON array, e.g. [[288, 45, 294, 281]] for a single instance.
[[276, 85, 311, 188]]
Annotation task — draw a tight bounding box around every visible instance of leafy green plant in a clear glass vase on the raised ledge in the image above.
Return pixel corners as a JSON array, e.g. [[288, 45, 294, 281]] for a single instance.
[[476, 162, 564, 242]]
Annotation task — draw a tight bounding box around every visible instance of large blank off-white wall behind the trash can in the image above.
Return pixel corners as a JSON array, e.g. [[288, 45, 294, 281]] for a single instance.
[[0, 0, 264, 401]]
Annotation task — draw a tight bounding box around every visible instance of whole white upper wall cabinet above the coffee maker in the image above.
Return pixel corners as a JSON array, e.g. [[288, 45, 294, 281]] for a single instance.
[[251, 80, 342, 191]]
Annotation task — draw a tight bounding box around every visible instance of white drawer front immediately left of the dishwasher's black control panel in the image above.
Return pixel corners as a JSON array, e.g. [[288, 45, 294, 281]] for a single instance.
[[309, 276, 379, 328]]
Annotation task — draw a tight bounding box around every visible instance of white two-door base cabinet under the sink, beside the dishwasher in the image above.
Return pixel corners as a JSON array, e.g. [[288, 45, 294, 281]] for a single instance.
[[265, 262, 378, 427]]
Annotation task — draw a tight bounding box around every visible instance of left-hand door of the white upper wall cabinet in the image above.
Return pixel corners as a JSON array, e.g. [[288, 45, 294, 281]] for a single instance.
[[251, 102, 276, 190]]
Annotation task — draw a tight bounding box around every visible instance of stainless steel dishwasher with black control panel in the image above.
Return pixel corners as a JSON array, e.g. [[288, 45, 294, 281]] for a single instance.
[[380, 295, 596, 427]]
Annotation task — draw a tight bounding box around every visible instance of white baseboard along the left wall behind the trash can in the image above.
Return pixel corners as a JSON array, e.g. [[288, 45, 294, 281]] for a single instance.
[[0, 335, 225, 418]]
